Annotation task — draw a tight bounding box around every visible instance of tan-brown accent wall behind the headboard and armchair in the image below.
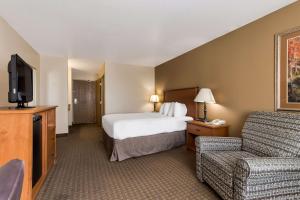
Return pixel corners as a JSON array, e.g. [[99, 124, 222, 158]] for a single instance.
[[155, 2, 300, 136]]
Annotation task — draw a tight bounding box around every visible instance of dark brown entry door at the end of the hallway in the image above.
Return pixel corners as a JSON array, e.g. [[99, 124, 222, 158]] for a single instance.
[[73, 80, 96, 124]]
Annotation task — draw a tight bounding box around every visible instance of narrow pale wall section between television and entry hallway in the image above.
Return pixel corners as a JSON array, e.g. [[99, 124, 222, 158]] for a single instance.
[[40, 55, 69, 134]]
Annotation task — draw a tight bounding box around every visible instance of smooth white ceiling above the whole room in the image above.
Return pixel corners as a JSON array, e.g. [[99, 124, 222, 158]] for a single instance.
[[0, 0, 295, 66]]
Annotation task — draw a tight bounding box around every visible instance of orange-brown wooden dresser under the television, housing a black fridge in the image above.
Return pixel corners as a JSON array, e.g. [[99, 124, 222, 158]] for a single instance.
[[0, 106, 56, 200]]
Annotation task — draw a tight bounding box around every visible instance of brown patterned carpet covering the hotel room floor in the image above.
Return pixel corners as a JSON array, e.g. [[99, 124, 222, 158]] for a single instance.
[[37, 125, 219, 200]]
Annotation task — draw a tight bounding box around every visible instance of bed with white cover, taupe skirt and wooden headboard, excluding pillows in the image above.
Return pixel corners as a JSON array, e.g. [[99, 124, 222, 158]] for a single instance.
[[102, 87, 198, 161]]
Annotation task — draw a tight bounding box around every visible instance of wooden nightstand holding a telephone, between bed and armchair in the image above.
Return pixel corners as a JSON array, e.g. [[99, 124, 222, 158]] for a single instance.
[[186, 120, 229, 151]]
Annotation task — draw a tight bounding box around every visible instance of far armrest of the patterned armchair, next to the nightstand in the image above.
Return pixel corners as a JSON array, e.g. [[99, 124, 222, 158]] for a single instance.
[[195, 136, 242, 153]]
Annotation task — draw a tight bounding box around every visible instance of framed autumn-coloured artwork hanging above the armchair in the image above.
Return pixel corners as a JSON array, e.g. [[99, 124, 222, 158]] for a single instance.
[[275, 27, 300, 111]]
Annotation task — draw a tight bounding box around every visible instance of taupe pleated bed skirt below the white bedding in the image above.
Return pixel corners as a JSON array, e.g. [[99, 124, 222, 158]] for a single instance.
[[103, 131, 185, 161]]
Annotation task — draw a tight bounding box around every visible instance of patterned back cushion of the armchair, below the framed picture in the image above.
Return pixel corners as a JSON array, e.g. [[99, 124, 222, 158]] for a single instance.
[[242, 112, 300, 157]]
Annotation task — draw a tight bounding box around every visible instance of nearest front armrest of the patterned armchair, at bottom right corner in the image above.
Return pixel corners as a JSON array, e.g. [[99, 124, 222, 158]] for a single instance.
[[234, 157, 300, 199]]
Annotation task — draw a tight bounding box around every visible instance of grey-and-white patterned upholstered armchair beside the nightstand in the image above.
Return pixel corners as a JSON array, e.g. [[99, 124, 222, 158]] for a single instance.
[[195, 112, 300, 200]]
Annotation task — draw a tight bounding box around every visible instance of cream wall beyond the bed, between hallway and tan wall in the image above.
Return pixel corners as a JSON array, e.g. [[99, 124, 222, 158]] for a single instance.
[[104, 63, 154, 114]]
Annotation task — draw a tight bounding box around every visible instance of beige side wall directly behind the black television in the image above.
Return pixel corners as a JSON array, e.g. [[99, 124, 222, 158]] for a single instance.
[[0, 17, 40, 106]]
